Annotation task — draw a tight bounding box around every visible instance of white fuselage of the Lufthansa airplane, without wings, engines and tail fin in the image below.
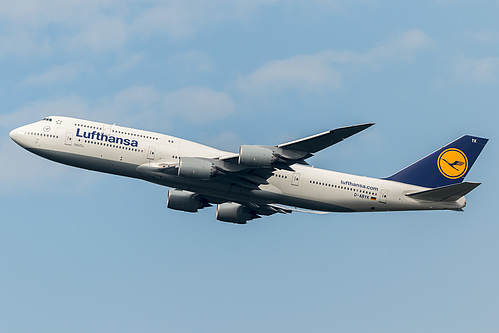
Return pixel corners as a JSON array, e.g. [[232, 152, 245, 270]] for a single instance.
[[11, 117, 465, 212]]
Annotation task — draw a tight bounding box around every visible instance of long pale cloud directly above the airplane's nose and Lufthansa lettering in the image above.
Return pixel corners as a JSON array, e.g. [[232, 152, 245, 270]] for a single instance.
[[0, 86, 235, 131]]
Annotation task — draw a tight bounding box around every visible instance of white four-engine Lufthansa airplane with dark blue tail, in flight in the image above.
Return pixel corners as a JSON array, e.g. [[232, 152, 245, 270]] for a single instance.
[[10, 116, 488, 224]]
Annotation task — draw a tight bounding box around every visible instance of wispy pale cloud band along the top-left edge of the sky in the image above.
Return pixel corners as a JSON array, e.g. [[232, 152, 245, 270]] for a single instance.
[[0, 0, 364, 55]]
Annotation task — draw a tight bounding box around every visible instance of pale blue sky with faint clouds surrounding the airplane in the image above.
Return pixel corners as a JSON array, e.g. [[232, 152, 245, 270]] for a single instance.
[[0, 0, 499, 333]]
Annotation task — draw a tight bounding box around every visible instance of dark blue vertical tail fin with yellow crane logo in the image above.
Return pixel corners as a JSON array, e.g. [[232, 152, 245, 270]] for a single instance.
[[385, 135, 489, 188]]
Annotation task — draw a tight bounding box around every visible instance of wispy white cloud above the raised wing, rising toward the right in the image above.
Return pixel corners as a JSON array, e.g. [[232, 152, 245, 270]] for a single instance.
[[237, 29, 433, 92]]
